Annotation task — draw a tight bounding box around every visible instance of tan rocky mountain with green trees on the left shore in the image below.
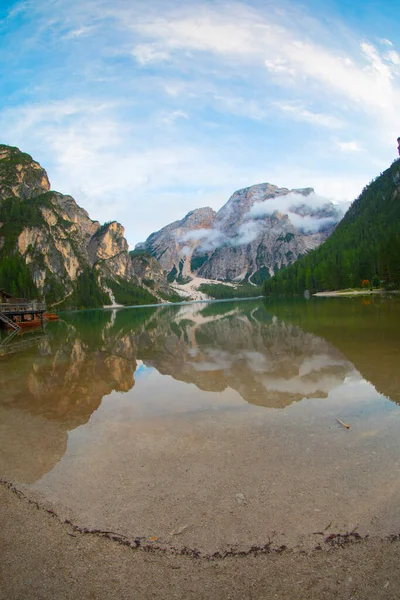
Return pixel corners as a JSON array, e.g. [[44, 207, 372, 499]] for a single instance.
[[0, 144, 176, 309]]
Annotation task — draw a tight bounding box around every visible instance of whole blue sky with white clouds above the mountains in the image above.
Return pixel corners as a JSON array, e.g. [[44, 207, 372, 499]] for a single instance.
[[0, 0, 400, 247]]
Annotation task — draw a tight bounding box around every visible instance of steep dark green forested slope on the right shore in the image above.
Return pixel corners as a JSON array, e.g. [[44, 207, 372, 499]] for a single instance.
[[264, 159, 400, 294]]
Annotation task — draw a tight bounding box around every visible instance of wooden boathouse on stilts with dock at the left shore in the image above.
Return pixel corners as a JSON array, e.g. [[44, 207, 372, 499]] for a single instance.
[[0, 290, 46, 331]]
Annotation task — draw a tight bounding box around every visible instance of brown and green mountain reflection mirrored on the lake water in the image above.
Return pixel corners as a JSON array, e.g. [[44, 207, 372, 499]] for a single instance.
[[0, 298, 400, 483]]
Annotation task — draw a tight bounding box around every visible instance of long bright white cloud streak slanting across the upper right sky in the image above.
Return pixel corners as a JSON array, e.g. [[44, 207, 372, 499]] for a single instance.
[[132, 5, 399, 122]]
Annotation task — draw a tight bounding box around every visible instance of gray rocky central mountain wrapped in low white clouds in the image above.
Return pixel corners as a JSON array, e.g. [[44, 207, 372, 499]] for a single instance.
[[142, 183, 340, 283]]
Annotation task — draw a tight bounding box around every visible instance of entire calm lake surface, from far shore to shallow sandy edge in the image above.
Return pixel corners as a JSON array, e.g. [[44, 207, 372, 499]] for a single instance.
[[0, 297, 400, 552]]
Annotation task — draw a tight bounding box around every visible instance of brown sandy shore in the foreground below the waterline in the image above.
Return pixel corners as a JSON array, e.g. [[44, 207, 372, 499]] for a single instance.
[[0, 485, 400, 600]]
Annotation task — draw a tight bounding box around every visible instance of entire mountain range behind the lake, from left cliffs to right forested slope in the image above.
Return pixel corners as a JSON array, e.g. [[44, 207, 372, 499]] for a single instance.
[[0, 145, 400, 308]]
